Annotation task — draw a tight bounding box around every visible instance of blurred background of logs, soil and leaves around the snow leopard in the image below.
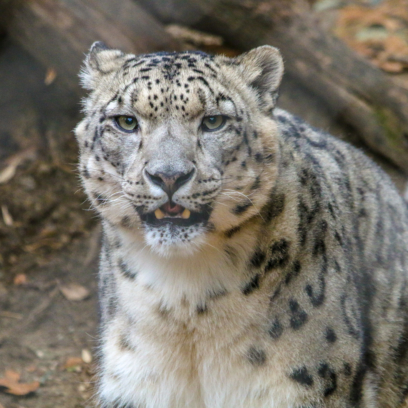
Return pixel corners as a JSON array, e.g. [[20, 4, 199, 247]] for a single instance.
[[0, 0, 408, 408]]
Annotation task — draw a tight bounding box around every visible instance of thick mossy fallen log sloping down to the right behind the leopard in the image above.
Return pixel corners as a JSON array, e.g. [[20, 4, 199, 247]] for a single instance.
[[138, 0, 408, 172]]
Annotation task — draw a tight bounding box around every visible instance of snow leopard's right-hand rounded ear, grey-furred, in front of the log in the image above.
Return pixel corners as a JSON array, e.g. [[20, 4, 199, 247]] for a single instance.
[[235, 45, 284, 108]]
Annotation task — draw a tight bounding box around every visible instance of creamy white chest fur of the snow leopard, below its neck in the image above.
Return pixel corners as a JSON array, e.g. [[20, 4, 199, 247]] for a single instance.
[[100, 231, 296, 408]]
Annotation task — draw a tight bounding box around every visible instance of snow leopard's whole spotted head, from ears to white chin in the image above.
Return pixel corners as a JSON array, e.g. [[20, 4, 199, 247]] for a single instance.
[[76, 43, 282, 254]]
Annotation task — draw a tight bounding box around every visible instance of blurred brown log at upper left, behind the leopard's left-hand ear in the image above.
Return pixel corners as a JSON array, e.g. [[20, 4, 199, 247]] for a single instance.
[[0, 0, 179, 93]]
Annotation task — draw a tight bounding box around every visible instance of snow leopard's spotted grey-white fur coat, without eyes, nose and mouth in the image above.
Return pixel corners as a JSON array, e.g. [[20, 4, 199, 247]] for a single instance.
[[76, 43, 408, 408]]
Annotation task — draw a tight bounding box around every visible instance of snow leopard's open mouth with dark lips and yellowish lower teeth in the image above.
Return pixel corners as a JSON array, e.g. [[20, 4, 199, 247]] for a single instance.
[[141, 201, 210, 227]]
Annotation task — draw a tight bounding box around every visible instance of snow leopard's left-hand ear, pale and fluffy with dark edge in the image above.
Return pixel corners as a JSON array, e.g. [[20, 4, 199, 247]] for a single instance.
[[80, 41, 125, 90]]
